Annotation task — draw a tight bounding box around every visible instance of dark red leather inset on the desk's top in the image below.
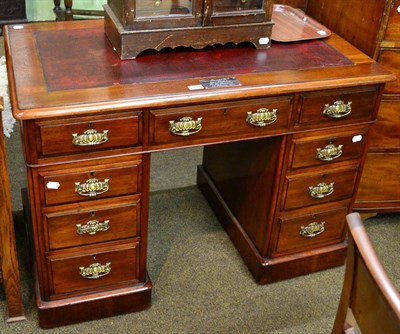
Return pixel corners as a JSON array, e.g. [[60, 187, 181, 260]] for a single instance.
[[35, 29, 353, 91]]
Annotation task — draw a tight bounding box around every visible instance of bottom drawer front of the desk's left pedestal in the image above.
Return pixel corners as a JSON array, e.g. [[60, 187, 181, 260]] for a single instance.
[[47, 243, 140, 295]]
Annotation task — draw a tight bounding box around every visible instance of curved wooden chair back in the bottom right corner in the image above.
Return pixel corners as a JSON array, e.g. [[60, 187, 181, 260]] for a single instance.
[[332, 213, 400, 334]]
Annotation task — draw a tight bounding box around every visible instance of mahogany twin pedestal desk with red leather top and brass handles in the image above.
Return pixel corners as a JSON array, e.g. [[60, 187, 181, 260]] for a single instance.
[[5, 20, 394, 328]]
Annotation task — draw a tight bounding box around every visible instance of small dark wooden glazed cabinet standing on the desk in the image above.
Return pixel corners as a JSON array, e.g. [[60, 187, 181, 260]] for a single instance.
[[104, 0, 273, 59]]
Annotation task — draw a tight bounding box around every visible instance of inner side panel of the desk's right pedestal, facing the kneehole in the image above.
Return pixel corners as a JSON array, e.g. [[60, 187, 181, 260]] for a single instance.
[[202, 136, 285, 253]]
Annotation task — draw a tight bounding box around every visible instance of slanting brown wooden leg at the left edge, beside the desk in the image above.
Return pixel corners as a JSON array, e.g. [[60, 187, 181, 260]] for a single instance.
[[0, 97, 26, 322]]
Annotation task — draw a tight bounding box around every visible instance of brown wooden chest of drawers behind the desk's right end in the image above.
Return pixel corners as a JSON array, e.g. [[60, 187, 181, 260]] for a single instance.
[[307, 0, 400, 212]]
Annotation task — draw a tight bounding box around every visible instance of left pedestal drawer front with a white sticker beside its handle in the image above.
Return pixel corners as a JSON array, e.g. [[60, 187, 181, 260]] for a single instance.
[[41, 162, 141, 205]]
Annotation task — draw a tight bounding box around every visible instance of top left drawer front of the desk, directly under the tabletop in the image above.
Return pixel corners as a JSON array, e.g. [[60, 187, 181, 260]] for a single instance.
[[36, 112, 142, 157]]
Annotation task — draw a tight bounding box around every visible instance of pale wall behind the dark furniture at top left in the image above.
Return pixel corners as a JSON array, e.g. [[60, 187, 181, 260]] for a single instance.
[[25, 0, 107, 21]]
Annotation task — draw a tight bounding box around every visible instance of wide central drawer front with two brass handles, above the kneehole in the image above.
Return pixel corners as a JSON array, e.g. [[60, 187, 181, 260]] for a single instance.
[[150, 96, 292, 145]]
